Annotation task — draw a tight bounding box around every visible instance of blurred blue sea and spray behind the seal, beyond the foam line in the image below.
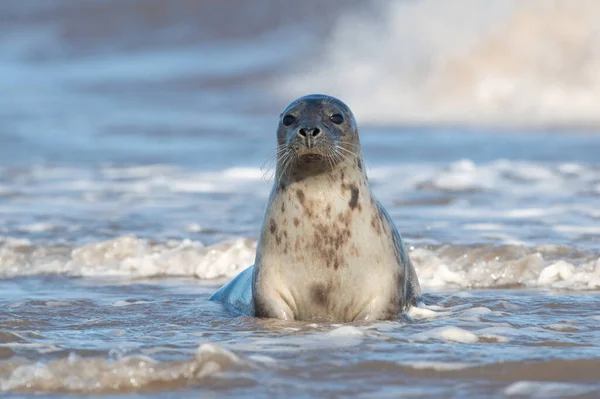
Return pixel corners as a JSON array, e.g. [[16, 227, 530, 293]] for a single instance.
[[0, 0, 600, 275]]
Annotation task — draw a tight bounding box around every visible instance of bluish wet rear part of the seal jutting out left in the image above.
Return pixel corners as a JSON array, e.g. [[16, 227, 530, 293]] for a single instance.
[[209, 265, 254, 316]]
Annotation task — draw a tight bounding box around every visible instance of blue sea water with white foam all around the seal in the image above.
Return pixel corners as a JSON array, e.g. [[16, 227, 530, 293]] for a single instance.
[[0, 0, 600, 397]]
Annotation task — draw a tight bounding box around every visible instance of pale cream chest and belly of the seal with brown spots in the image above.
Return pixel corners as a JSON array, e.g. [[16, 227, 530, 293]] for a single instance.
[[256, 172, 403, 321]]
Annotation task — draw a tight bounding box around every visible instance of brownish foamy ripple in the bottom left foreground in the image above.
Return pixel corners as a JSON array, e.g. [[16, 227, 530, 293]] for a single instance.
[[0, 344, 256, 394]]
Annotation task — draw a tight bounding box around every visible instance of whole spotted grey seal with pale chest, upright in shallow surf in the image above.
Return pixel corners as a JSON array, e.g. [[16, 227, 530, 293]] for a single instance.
[[211, 94, 421, 322]]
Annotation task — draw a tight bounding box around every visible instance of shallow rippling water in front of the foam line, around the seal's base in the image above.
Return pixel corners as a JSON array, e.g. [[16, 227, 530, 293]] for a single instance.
[[0, 276, 600, 397]]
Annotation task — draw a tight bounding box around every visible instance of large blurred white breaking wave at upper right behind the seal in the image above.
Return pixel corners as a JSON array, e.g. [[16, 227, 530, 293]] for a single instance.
[[284, 0, 600, 126]]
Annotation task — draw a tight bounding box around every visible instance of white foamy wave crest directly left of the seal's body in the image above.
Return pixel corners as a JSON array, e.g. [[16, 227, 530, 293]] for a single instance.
[[0, 236, 256, 279]]
